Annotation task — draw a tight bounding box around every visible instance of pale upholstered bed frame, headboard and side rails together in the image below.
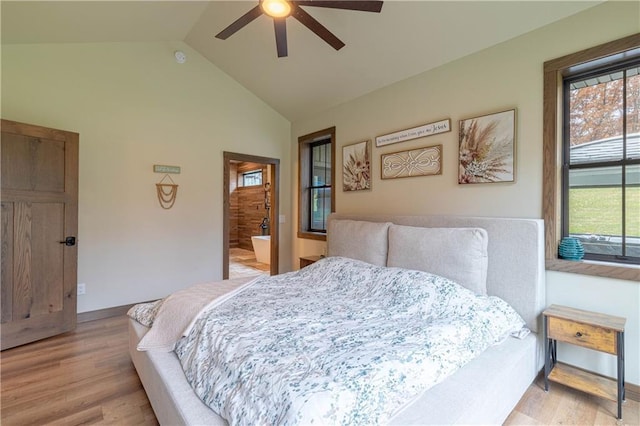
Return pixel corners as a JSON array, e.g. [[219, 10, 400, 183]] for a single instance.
[[129, 214, 545, 425]]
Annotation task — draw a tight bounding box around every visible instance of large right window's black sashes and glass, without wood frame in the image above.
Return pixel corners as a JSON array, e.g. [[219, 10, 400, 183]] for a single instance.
[[562, 62, 640, 264]]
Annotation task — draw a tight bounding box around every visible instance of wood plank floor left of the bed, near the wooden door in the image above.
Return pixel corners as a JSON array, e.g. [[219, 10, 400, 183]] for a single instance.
[[0, 316, 158, 426]]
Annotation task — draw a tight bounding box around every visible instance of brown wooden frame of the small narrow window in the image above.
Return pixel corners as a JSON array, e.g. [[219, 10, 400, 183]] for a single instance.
[[298, 127, 336, 241]]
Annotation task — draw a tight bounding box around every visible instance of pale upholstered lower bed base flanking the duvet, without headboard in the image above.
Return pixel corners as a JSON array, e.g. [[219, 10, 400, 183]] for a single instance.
[[129, 319, 542, 425]]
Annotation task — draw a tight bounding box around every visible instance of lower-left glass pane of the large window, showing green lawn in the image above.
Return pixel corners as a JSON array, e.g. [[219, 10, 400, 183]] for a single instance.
[[569, 167, 622, 255]]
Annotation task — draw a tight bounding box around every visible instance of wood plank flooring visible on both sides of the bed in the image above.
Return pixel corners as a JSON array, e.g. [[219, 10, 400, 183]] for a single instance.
[[0, 316, 640, 426]]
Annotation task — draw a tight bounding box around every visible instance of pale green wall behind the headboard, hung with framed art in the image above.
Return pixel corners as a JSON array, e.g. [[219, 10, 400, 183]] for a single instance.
[[292, 1, 640, 384]]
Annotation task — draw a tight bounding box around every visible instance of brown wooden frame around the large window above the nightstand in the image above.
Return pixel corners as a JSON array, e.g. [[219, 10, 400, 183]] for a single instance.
[[542, 33, 640, 281]]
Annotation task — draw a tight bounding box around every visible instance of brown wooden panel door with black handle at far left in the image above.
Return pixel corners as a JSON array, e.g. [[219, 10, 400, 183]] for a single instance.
[[0, 120, 78, 350]]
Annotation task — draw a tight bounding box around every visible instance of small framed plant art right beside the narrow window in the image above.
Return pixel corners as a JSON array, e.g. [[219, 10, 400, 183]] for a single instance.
[[342, 141, 371, 191]]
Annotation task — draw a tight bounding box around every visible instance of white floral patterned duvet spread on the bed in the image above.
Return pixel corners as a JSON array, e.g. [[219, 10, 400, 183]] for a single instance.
[[175, 257, 528, 425]]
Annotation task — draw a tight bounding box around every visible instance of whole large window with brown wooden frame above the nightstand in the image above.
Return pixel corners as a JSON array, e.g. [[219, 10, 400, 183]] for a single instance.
[[543, 34, 640, 280]]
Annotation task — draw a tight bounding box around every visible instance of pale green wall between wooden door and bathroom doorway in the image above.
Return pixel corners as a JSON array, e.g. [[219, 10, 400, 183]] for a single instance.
[[2, 43, 292, 312]]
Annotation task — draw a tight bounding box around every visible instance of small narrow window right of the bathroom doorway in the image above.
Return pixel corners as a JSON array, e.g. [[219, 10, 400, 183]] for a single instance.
[[298, 127, 335, 240]]
